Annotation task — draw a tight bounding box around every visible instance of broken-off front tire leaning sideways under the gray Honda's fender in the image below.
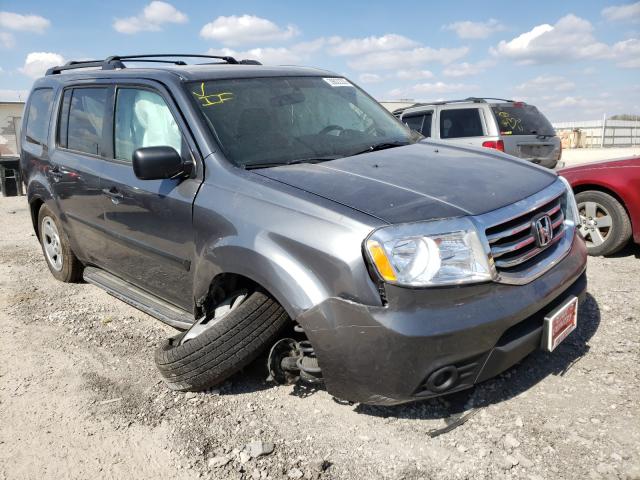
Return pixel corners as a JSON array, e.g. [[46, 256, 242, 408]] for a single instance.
[[155, 291, 289, 391]]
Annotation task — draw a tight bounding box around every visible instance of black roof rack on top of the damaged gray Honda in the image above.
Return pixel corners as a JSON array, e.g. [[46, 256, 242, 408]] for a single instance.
[[46, 53, 262, 75]]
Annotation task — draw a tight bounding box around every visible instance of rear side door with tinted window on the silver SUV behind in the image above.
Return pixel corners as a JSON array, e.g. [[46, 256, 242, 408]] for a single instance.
[[438, 105, 487, 147]]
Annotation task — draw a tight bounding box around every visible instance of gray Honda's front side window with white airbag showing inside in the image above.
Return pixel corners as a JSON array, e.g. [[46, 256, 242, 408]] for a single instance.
[[114, 88, 182, 162]]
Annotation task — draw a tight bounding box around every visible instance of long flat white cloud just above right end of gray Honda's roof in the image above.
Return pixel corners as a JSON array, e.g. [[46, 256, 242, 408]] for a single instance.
[[348, 47, 469, 70]]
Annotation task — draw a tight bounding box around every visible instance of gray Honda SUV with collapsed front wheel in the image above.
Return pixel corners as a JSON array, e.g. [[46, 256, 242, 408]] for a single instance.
[[21, 55, 586, 405]]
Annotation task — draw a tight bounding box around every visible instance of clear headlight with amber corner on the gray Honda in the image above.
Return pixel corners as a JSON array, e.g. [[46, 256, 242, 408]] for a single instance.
[[365, 218, 495, 287]]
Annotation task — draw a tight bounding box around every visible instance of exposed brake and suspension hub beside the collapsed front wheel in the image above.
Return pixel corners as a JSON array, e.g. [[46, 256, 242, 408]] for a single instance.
[[267, 325, 323, 385]]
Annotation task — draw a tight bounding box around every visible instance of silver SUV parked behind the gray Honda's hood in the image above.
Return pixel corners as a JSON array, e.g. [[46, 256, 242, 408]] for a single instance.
[[393, 97, 562, 168]]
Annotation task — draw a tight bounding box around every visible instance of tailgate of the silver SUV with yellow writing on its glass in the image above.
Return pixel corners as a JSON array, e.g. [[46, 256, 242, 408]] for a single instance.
[[491, 102, 561, 163]]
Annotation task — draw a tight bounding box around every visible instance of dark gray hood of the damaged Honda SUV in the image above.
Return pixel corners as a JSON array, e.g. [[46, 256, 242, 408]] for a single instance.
[[253, 142, 556, 223]]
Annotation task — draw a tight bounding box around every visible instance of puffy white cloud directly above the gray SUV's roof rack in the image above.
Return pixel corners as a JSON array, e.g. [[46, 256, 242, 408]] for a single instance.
[[200, 15, 300, 46]]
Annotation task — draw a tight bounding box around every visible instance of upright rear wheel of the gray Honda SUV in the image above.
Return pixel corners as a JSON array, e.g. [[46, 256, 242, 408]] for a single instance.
[[38, 205, 83, 283]]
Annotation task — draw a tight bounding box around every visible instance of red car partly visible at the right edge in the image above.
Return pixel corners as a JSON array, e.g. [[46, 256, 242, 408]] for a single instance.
[[558, 157, 640, 255]]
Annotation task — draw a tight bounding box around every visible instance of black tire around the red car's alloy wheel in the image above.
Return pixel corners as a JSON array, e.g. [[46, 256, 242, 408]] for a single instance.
[[576, 190, 632, 256]]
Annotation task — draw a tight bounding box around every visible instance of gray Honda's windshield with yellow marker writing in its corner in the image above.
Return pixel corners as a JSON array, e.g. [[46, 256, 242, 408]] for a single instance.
[[187, 77, 421, 168]]
